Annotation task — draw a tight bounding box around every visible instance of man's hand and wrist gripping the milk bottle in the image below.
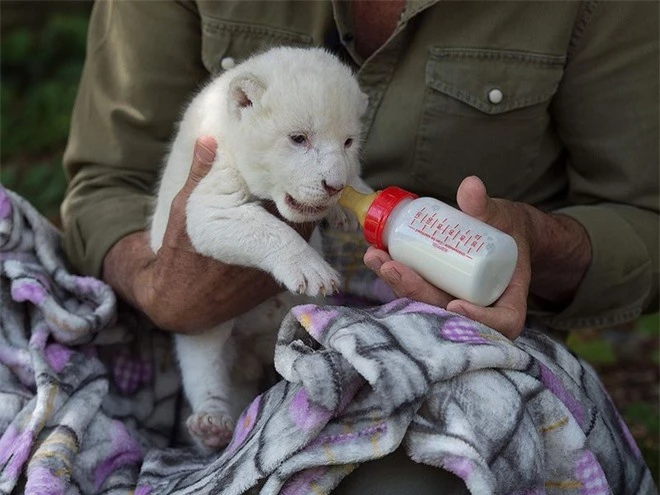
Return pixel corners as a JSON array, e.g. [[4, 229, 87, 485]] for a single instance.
[[364, 177, 591, 339]]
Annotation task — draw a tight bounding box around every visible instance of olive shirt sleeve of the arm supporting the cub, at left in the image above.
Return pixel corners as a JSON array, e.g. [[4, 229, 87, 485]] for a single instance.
[[61, 0, 208, 277]]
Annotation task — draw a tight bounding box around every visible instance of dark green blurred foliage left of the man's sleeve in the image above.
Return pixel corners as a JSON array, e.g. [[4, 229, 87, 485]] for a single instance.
[[0, 14, 87, 223]]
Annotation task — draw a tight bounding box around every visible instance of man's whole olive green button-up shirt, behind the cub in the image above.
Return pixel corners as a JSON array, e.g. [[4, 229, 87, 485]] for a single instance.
[[62, 0, 660, 329]]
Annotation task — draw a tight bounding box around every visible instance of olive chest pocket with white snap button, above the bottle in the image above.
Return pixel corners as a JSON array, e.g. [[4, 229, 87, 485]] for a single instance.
[[413, 48, 565, 199]]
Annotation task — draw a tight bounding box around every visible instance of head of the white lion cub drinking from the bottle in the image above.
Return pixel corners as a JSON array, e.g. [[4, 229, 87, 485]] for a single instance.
[[226, 48, 367, 222]]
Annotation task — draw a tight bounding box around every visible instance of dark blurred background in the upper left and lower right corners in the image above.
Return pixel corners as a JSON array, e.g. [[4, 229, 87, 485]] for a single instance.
[[0, 0, 660, 483]]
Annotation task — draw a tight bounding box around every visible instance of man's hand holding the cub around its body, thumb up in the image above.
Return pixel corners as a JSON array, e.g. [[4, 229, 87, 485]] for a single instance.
[[103, 137, 306, 333]]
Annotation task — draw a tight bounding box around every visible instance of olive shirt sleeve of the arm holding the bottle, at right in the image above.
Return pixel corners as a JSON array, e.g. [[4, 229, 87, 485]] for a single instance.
[[532, 1, 660, 329]]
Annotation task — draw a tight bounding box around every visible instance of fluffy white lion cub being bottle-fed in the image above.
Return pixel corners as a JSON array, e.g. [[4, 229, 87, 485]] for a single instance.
[[151, 47, 369, 449]]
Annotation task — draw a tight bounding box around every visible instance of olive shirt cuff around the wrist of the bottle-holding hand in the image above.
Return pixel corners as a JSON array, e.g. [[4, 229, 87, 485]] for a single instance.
[[529, 206, 651, 330]]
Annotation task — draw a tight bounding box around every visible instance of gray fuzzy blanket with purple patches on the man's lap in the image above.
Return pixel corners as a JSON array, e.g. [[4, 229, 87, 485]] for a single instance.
[[0, 188, 657, 495]]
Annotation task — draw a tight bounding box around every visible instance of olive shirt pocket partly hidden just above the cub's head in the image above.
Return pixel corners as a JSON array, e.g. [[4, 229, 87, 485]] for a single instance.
[[202, 16, 313, 75]]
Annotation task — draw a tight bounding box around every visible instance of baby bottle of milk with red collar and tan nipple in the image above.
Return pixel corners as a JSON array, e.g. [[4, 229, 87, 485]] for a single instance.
[[339, 187, 518, 306]]
